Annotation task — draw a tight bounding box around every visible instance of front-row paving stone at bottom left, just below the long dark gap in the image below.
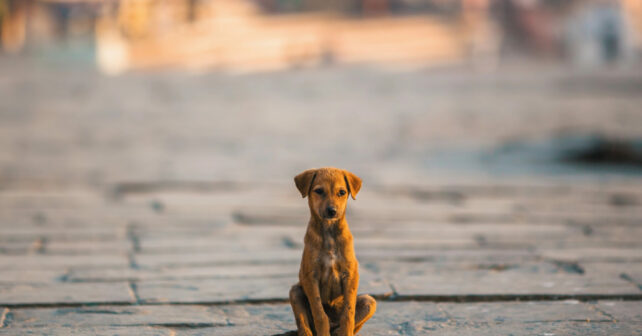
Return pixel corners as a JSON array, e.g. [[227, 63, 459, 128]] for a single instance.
[[9, 305, 228, 328]]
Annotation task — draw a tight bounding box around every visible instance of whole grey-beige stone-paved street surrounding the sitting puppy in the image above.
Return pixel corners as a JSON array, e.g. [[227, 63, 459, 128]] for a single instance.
[[0, 60, 642, 336]]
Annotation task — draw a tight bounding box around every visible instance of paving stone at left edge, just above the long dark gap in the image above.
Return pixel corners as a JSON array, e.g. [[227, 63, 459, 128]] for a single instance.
[[0, 282, 136, 306]]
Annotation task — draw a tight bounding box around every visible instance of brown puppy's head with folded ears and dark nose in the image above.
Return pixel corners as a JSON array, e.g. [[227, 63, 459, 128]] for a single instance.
[[294, 168, 361, 221]]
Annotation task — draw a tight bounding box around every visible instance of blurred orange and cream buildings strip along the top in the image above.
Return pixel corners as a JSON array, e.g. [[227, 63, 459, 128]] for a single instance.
[[0, 0, 642, 73]]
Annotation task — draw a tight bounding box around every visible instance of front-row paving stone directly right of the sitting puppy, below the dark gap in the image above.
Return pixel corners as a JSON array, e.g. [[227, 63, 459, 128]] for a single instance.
[[363, 301, 632, 335]]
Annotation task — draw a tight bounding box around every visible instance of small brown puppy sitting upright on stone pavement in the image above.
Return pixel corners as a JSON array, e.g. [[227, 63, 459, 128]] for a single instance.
[[290, 168, 377, 336]]
